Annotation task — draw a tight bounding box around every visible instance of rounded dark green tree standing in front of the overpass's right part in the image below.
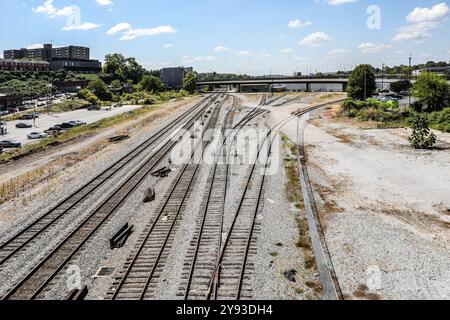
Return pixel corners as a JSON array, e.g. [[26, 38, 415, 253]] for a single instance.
[[348, 64, 377, 100]]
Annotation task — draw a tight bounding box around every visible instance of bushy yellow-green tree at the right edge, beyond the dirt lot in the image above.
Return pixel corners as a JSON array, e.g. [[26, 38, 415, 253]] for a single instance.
[[413, 72, 450, 112]]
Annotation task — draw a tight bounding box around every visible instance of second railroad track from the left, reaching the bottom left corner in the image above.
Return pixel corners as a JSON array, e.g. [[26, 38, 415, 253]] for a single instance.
[[3, 95, 225, 300]]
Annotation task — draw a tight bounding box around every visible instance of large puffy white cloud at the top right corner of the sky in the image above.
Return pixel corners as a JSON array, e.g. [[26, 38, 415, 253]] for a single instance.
[[392, 3, 450, 42]]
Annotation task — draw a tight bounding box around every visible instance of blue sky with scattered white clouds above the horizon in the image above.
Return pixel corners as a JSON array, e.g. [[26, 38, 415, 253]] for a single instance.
[[0, 0, 450, 75]]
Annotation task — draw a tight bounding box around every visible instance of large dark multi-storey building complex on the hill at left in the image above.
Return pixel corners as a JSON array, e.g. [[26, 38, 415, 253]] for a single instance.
[[0, 44, 102, 73]]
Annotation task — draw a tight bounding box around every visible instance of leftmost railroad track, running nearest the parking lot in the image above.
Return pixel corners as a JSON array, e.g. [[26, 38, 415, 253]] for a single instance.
[[0, 97, 216, 266]]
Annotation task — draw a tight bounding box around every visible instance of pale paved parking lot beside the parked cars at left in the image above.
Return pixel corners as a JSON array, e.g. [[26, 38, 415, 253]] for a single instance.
[[0, 105, 141, 146]]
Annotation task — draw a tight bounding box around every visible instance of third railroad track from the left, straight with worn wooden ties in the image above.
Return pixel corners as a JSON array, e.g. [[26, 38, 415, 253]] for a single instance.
[[106, 97, 225, 300]]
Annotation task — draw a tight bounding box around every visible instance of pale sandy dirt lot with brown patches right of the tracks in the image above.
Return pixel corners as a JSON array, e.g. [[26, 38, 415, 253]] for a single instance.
[[298, 108, 450, 299]]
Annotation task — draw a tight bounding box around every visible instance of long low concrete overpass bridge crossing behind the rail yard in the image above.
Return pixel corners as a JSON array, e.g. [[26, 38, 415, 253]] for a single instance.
[[197, 78, 398, 92]]
